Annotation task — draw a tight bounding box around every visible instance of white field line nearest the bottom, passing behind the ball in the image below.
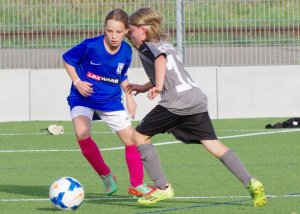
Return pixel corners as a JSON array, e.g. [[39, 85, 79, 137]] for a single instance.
[[0, 193, 300, 202]]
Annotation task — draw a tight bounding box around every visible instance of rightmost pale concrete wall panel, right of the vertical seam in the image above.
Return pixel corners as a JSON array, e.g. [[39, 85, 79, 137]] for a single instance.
[[217, 66, 300, 118]]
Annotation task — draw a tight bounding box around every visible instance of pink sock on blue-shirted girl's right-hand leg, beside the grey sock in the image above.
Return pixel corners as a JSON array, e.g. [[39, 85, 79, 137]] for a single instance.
[[125, 145, 144, 187]]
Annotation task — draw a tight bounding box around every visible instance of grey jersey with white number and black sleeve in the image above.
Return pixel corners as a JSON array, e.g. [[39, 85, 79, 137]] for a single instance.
[[139, 40, 207, 115]]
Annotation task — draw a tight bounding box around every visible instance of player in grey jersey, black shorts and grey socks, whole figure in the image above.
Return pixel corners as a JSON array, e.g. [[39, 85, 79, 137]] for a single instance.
[[127, 8, 266, 206]]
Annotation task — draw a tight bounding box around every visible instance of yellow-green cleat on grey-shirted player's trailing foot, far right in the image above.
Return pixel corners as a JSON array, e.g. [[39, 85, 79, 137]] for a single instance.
[[247, 178, 267, 207]]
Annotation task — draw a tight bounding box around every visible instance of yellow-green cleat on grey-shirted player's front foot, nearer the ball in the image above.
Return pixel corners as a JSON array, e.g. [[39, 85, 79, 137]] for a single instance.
[[138, 184, 174, 205]]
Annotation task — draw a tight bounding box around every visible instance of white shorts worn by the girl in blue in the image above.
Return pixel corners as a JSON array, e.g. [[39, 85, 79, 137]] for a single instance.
[[71, 106, 131, 132]]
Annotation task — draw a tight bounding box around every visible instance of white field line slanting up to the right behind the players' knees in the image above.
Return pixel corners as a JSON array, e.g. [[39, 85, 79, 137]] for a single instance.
[[0, 129, 300, 153]]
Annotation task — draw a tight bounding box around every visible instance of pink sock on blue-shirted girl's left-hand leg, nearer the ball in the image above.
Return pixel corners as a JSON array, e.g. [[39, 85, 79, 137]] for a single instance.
[[78, 137, 110, 177]]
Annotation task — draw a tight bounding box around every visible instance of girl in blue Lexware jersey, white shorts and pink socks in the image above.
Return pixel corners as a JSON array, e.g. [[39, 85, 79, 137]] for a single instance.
[[63, 9, 151, 196]]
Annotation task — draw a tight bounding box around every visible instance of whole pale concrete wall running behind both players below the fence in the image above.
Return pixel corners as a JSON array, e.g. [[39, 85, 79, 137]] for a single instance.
[[0, 65, 300, 122]]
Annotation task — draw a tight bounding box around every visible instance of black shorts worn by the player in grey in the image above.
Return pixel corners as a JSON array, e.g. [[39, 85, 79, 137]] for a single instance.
[[136, 105, 217, 143]]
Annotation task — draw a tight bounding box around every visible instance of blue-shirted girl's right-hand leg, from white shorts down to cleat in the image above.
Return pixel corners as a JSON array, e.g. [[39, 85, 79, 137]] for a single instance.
[[97, 111, 152, 197]]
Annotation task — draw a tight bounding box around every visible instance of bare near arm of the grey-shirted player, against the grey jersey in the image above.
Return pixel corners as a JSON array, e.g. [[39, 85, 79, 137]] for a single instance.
[[147, 55, 167, 100]]
